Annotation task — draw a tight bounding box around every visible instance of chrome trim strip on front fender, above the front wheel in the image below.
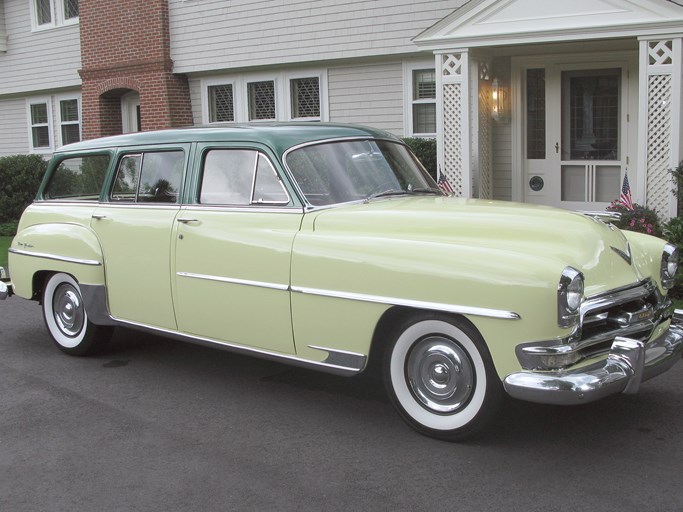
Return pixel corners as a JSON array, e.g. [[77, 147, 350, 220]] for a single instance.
[[291, 286, 522, 320]]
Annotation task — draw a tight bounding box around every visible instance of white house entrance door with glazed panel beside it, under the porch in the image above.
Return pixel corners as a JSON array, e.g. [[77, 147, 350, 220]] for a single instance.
[[523, 61, 636, 210]]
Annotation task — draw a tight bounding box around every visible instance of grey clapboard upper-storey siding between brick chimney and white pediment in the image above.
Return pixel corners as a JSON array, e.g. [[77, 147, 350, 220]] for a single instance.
[[169, 0, 466, 73]]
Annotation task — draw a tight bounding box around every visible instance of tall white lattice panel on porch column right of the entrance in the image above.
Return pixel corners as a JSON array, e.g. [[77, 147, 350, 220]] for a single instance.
[[647, 75, 672, 214]]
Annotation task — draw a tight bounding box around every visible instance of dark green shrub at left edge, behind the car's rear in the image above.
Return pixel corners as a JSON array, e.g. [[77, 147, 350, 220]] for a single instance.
[[0, 155, 47, 223]]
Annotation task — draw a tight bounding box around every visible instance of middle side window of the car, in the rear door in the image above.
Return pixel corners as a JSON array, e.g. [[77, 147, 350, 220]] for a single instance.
[[111, 151, 185, 203]]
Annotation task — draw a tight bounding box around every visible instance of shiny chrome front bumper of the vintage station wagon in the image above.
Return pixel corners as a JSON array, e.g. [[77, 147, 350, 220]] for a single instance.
[[503, 322, 683, 405]]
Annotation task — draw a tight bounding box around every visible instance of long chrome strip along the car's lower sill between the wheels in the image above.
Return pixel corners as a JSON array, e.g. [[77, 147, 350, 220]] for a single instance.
[[115, 319, 364, 376]]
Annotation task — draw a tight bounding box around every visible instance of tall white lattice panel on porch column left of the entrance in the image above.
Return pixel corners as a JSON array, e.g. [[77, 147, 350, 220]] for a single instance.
[[443, 84, 467, 197]]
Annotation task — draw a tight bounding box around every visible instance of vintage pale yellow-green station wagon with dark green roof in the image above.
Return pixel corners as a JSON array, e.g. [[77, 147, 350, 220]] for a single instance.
[[0, 123, 683, 439]]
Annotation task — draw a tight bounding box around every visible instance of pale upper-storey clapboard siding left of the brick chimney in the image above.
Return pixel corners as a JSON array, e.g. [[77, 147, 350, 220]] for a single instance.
[[0, 0, 81, 97]]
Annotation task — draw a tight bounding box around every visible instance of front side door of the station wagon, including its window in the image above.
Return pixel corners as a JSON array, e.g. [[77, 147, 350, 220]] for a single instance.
[[174, 145, 303, 353]]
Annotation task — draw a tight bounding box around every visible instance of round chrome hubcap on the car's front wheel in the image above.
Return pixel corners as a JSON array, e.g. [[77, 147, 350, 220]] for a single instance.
[[406, 336, 475, 414]]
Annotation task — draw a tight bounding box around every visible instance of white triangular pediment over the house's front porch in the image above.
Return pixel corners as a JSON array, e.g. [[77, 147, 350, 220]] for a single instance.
[[413, 0, 683, 49]]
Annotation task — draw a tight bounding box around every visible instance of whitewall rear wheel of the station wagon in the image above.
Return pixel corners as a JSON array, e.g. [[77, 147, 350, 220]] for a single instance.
[[43, 273, 112, 356]]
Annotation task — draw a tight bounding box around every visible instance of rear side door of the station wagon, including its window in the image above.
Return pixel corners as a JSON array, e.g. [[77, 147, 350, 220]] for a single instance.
[[90, 145, 190, 330]]
